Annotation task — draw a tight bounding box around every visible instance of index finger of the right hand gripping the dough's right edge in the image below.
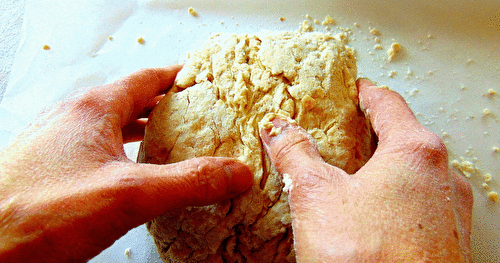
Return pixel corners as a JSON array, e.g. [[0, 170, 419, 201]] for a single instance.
[[356, 79, 436, 151]]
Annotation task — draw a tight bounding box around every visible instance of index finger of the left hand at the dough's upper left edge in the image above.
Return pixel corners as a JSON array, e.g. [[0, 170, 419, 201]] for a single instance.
[[109, 65, 182, 127]]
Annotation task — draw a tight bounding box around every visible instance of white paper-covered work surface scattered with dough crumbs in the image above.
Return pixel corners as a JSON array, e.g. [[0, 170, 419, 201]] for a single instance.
[[0, 0, 500, 262]]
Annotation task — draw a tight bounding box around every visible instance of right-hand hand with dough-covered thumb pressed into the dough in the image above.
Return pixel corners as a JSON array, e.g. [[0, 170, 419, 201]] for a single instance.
[[261, 80, 473, 262]]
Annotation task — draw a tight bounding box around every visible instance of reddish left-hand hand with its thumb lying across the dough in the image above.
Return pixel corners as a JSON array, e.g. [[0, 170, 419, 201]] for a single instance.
[[0, 66, 252, 262]]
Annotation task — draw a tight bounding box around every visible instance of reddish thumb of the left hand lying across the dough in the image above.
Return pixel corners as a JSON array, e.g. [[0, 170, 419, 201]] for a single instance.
[[106, 157, 253, 227]]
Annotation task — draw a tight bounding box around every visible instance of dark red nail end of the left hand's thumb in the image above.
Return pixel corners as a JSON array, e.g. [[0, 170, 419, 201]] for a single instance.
[[224, 163, 253, 195]]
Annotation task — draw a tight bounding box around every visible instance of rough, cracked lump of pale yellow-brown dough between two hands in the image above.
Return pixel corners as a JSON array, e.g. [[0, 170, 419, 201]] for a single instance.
[[140, 32, 373, 262]]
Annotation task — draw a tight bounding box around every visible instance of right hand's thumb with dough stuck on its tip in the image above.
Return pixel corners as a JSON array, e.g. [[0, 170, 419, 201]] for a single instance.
[[260, 118, 343, 180]]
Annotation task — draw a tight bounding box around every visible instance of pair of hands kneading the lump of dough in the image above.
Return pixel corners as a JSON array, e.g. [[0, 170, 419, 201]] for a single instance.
[[0, 66, 472, 262]]
